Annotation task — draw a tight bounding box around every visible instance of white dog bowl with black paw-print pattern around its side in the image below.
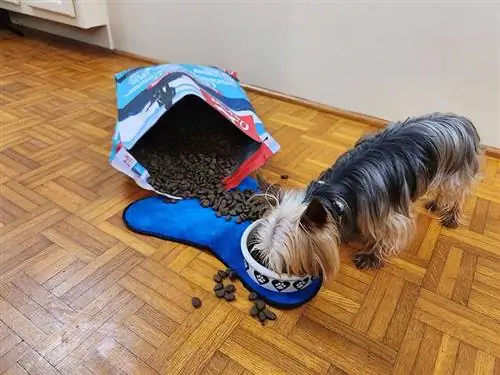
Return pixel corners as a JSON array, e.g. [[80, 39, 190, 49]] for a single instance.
[[241, 219, 312, 293]]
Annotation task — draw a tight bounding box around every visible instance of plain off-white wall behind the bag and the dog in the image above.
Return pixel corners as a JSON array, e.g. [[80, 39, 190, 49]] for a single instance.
[[108, 0, 500, 147]]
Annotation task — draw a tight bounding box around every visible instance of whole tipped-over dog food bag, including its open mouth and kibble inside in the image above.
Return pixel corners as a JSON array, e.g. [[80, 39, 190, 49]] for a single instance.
[[109, 64, 280, 198]]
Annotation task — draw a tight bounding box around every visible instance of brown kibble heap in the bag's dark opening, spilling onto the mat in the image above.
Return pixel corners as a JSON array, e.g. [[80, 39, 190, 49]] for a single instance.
[[130, 101, 264, 223]]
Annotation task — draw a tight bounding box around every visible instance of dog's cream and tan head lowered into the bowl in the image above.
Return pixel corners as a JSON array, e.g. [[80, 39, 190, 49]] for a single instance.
[[253, 179, 340, 278]]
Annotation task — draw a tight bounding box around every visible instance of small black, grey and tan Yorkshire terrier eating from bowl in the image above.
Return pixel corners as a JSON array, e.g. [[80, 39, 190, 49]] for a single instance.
[[254, 113, 481, 278]]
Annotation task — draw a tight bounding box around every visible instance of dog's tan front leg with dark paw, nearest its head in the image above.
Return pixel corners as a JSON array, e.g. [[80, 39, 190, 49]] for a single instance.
[[354, 211, 415, 269]]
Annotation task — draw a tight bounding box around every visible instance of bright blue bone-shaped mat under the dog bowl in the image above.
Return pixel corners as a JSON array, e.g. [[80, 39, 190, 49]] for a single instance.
[[123, 178, 322, 308]]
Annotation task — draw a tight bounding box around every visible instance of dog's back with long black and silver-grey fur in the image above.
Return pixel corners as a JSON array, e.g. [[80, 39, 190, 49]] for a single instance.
[[325, 113, 480, 201]]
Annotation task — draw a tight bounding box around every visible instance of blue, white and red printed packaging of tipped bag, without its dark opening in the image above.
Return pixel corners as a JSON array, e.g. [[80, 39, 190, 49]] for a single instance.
[[109, 64, 280, 191]]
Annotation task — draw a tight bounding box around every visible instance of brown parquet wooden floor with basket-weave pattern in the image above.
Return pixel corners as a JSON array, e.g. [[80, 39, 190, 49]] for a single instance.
[[0, 31, 500, 375]]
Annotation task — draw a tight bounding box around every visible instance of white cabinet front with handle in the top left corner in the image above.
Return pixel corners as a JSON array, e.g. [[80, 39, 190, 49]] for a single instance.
[[0, 0, 108, 29]]
